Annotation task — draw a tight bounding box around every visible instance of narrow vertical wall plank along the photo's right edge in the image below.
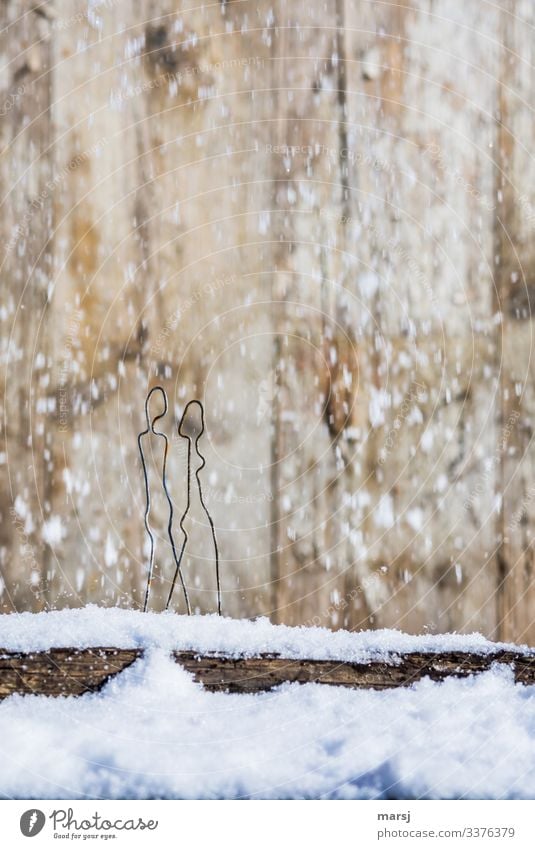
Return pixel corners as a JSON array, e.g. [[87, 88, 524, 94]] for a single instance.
[[495, 0, 535, 643]]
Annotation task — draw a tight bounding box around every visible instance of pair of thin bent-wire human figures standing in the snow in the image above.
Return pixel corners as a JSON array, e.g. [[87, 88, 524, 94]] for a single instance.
[[137, 386, 221, 616]]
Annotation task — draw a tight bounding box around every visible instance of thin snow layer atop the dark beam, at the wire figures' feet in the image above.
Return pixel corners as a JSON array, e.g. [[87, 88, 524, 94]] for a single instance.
[[0, 605, 528, 662]]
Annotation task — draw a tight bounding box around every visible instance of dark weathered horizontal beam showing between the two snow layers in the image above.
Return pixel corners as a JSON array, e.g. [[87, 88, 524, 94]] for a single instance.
[[0, 647, 535, 699]]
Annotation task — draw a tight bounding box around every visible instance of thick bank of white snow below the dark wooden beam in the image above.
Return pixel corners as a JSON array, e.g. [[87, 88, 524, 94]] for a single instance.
[[0, 649, 535, 799]]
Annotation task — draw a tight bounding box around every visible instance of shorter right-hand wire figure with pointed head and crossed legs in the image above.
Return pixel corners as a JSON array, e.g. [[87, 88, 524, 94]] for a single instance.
[[166, 400, 221, 616]]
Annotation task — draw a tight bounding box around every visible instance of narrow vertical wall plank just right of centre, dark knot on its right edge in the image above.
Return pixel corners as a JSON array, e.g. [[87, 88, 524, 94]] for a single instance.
[[272, 0, 359, 627]]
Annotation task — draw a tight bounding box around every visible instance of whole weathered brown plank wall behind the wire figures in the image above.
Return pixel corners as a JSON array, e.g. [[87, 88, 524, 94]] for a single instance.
[[0, 0, 535, 642]]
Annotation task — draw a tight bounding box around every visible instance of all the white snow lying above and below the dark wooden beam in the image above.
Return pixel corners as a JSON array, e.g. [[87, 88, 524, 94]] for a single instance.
[[0, 605, 535, 799]]
